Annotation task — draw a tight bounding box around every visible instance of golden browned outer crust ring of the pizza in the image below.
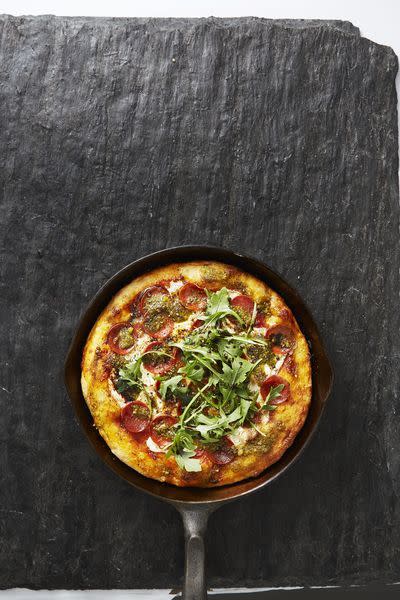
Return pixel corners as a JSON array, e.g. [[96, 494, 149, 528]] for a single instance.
[[82, 261, 311, 487]]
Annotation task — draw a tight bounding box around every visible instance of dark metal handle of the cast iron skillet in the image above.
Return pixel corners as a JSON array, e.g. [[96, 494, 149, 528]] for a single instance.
[[179, 507, 214, 600]]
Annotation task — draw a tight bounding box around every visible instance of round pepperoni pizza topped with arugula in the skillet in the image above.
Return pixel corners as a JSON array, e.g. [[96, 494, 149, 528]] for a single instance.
[[82, 261, 311, 487]]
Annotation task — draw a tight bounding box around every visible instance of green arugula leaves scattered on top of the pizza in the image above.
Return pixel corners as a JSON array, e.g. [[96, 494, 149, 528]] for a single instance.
[[119, 288, 283, 471]]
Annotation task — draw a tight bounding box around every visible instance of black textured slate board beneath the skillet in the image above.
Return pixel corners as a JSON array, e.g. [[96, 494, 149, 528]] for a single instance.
[[0, 16, 400, 588]]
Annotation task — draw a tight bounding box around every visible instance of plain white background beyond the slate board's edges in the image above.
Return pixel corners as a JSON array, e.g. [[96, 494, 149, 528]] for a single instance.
[[0, 0, 400, 600]]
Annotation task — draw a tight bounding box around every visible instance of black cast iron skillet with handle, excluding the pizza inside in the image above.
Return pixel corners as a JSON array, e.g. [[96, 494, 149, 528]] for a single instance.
[[65, 246, 333, 600]]
